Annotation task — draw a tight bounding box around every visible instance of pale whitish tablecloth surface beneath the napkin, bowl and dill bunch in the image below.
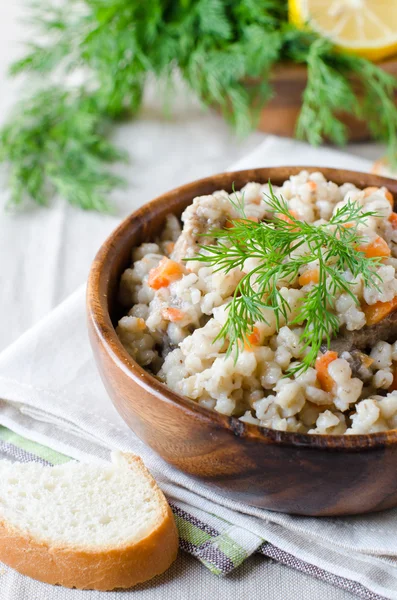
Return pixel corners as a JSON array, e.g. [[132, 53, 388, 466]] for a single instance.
[[0, 0, 383, 600]]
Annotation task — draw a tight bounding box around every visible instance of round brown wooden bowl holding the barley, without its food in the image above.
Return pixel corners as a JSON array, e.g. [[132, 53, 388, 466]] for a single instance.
[[87, 167, 397, 515]]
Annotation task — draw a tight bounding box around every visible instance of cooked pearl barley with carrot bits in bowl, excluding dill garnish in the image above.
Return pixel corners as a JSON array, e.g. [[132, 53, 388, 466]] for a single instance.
[[117, 171, 397, 435]]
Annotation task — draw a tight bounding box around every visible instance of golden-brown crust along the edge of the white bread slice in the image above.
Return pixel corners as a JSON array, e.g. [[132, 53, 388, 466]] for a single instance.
[[0, 455, 178, 591]]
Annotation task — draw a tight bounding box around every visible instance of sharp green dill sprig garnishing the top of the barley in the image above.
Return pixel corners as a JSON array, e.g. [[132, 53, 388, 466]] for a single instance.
[[193, 184, 380, 374]]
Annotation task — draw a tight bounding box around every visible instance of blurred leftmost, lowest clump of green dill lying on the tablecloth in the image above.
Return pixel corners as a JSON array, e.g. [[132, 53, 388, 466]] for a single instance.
[[0, 87, 126, 212]]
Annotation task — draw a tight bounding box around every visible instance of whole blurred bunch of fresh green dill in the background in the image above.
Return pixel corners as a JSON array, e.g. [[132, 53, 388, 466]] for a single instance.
[[0, 0, 397, 210]]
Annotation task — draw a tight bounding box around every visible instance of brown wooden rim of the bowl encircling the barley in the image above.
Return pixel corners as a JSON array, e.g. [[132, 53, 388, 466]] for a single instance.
[[87, 166, 397, 452]]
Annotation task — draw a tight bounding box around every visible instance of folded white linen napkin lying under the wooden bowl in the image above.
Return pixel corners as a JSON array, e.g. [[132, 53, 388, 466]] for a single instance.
[[0, 138, 397, 599]]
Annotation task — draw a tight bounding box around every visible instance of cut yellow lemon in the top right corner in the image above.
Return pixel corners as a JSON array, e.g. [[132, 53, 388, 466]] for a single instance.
[[289, 0, 397, 61]]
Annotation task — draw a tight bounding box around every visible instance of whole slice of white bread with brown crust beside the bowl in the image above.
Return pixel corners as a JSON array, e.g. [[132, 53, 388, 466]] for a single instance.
[[0, 453, 178, 590]]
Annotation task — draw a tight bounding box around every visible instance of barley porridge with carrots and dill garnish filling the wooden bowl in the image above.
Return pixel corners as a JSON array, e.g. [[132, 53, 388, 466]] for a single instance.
[[117, 171, 397, 434]]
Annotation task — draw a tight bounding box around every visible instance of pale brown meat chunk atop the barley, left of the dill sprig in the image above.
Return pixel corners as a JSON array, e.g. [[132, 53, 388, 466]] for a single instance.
[[171, 192, 237, 261]]
